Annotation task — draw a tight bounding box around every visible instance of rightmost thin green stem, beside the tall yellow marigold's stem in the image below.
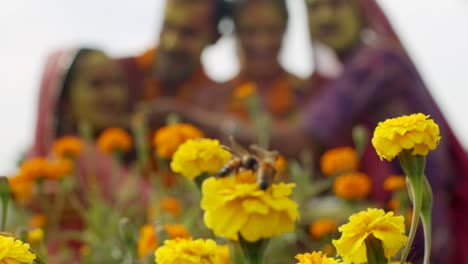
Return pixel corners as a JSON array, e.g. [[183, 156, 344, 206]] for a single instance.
[[421, 177, 432, 264]]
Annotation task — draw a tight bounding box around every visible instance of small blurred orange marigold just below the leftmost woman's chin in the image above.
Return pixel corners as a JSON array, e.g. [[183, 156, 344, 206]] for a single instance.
[[97, 128, 132, 154]]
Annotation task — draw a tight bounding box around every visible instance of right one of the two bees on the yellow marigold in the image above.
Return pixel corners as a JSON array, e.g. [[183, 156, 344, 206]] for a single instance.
[[250, 145, 279, 190]]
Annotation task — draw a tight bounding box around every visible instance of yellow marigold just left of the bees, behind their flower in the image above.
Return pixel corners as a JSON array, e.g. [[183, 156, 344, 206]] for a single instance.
[[171, 138, 231, 179]]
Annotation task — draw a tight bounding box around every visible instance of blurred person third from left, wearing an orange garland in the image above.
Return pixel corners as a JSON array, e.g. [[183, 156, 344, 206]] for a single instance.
[[218, 0, 314, 118]]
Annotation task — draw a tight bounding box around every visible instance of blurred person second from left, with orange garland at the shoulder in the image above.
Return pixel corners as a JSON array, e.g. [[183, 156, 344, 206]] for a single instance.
[[120, 0, 229, 108]]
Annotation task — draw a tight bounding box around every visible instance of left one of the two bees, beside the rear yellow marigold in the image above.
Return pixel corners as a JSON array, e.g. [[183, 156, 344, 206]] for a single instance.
[[217, 136, 258, 177]]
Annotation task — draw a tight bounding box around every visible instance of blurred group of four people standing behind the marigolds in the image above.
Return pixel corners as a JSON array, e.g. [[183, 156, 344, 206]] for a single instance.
[[27, 0, 468, 263]]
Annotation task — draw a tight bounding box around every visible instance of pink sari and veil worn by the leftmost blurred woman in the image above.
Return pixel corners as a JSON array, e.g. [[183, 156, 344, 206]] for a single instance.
[[28, 49, 150, 257]]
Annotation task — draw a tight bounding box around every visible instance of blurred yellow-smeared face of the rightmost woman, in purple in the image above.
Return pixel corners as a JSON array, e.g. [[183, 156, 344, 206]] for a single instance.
[[306, 0, 363, 54]]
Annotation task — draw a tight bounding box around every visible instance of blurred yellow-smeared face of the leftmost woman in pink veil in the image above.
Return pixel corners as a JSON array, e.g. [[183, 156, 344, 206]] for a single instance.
[[69, 52, 128, 130]]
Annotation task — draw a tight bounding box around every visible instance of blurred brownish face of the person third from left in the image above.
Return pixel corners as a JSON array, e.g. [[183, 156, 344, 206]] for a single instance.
[[236, 1, 286, 76]]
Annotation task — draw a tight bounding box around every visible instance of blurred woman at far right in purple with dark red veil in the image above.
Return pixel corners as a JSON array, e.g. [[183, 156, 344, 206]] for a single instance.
[[303, 0, 468, 263]]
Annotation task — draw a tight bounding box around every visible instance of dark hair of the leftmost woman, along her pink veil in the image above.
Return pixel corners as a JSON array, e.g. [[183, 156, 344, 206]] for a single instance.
[[54, 48, 102, 135]]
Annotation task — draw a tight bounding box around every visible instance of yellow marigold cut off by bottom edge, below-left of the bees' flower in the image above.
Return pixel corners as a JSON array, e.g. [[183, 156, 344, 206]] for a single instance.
[[154, 238, 217, 264]]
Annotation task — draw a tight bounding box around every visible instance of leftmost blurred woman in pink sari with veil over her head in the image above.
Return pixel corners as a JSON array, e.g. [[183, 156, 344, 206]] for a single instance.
[[27, 48, 149, 257]]
